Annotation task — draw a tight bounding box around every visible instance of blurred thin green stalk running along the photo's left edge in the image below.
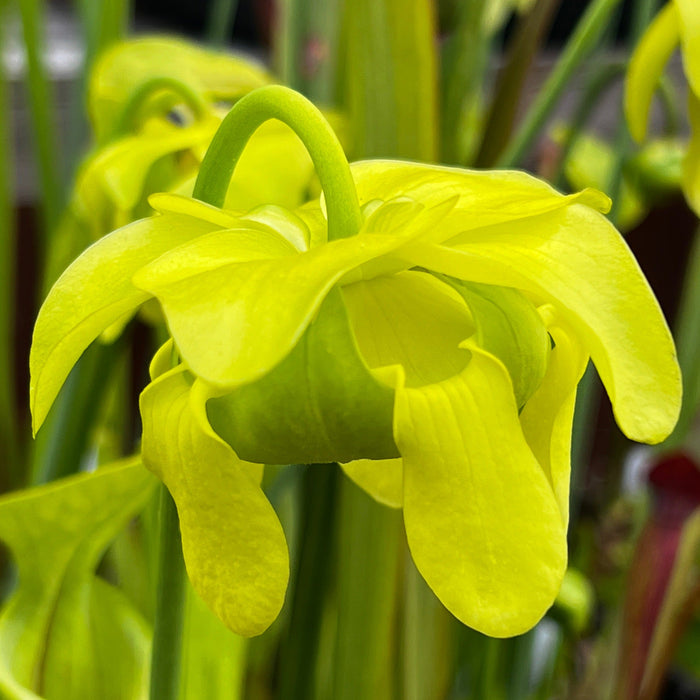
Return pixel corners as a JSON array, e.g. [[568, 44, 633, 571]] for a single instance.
[[0, 6, 21, 489]]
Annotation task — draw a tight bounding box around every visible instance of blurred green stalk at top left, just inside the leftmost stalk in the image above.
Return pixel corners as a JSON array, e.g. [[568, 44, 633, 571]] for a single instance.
[[19, 0, 63, 246]]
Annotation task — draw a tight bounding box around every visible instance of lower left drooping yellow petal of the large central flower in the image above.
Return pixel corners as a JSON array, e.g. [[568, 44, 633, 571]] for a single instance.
[[141, 367, 289, 637]]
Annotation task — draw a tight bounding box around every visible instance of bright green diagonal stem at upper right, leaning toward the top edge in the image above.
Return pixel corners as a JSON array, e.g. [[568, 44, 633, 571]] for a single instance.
[[497, 0, 621, 168]]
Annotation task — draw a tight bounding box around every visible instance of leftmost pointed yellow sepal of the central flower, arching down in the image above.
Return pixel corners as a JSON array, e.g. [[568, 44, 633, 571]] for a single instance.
[[29, 216, 221, 433]]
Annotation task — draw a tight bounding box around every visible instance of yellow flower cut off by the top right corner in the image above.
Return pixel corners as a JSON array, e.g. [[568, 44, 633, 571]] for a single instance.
[[625, 0, 700, 213]]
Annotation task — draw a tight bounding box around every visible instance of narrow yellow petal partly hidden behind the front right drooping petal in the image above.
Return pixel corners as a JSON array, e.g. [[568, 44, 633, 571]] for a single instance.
[[520, 312, 588, 527]]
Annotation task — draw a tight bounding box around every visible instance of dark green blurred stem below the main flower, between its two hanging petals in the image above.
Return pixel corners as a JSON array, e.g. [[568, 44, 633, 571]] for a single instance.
[[277, 464, 339, 700]]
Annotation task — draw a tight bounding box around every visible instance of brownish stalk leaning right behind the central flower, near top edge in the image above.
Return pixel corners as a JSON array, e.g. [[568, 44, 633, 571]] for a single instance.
[[476, 0, 560, 167]]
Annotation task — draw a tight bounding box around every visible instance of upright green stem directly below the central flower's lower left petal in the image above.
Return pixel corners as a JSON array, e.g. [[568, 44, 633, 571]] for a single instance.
[[150, 486, 187, 700]]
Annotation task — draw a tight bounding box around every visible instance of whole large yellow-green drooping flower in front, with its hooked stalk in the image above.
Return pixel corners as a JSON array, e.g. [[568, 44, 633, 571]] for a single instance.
[[31, 87, 680, 637]]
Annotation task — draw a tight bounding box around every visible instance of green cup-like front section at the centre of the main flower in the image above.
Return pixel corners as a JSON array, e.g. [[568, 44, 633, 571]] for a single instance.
[[207, 289, 399, 464]]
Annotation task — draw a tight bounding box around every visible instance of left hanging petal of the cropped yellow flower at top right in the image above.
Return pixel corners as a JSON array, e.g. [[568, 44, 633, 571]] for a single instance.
[[625, 2, 680, 141]]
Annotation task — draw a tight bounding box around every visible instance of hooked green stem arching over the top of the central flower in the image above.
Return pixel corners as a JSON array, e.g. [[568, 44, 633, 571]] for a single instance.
[[193, 85, 362, 240]]
